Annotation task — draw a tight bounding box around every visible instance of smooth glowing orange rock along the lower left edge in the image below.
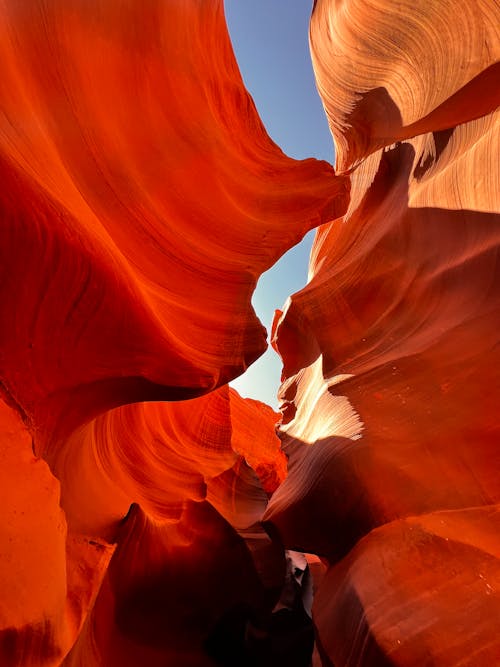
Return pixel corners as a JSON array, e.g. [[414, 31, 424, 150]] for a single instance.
[[0, 402, 113, 666]]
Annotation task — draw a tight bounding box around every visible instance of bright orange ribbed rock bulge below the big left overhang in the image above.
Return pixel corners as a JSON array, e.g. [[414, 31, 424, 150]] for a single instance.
[[49, 386, 286, 541]]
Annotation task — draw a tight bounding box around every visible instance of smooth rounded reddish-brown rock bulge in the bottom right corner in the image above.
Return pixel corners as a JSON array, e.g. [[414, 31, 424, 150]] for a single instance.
[[315, 504, 500, 667]]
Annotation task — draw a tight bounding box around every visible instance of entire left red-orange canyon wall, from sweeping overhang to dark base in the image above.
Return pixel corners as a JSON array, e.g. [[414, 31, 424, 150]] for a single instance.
[[0, 0, 348, 667]]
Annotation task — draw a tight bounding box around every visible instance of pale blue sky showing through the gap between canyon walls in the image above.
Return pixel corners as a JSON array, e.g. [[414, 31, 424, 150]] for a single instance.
[[224, 0, 333, 408]]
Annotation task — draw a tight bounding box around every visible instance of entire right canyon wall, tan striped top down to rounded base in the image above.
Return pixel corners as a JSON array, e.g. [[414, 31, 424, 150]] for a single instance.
[[264, 0, 500, 667]]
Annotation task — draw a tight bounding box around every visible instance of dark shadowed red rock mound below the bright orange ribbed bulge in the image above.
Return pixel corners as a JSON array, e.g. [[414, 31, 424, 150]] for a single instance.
[[64, 502, 283, 667]]
